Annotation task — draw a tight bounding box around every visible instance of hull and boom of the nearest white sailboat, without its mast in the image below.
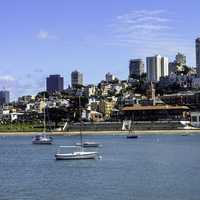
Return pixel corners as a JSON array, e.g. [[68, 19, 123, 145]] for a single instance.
[[55, 146, 98, 160]]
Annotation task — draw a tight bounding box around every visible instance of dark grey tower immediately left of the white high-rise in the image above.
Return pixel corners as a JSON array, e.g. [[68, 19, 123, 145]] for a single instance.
[[129, 59, 144, 78]]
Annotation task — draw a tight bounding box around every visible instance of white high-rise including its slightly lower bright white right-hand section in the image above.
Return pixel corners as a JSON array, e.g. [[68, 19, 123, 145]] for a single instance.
[[146, 55, 169, 81]]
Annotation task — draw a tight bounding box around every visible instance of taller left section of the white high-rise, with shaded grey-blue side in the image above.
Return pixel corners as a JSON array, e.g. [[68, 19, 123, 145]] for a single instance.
[[146, 55, 161, 81]]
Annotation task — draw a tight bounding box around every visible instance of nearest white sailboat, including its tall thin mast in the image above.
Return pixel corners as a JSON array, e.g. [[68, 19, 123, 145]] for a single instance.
[[55, 97, 98, 160]]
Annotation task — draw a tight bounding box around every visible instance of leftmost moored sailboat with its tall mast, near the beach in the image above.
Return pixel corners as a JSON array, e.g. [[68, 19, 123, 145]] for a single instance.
[[32, 96, 53, 144]]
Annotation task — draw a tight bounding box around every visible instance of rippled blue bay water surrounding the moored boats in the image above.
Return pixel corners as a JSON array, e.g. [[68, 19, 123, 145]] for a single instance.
[[0, 135, 200, 200]]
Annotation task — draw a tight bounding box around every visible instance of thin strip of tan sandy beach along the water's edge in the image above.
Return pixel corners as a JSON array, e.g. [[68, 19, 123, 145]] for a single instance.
[[0, 129, 200, 136]]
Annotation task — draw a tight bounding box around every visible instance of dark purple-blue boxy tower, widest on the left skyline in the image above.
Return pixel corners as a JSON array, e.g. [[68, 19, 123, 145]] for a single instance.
[[46, 74, 64, 93]]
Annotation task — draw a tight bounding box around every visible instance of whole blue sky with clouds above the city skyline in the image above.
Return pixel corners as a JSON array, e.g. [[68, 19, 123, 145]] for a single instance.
[[0, 0, 200, 99]]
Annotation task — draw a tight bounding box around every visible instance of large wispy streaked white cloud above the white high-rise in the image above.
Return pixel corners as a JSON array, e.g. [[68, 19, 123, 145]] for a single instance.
[[104, 10, 194, 63]]
